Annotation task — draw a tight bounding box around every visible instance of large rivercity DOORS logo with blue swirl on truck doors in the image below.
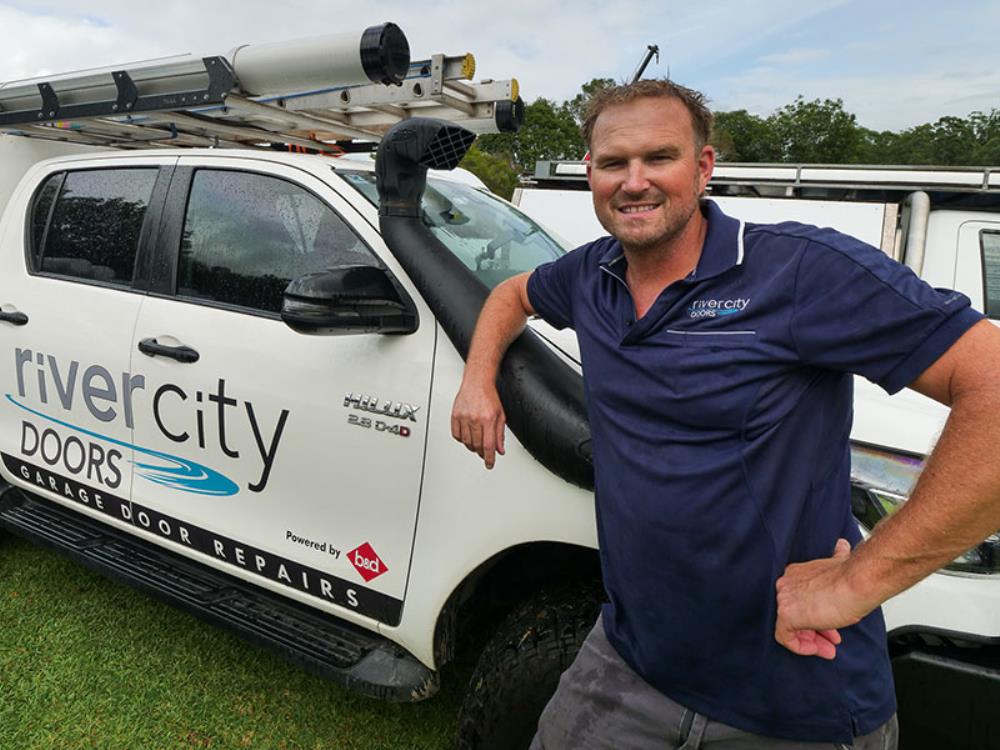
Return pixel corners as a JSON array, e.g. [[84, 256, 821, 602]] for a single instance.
[[6, 348, 289, 496]]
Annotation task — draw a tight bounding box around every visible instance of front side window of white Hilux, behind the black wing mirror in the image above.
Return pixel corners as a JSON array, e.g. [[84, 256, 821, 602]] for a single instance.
[[177, 169, 380, 312]]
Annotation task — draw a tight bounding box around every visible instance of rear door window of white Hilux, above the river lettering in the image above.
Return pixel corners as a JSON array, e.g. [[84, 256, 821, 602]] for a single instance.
[[35, 168, 157, 284]]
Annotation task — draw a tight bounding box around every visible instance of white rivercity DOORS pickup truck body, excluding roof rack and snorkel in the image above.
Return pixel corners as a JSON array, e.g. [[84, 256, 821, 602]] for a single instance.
[[0, 134, 600, 748]]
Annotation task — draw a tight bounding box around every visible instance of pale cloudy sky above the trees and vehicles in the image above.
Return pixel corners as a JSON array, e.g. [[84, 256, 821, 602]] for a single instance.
[[0, 0, 1000, 130]]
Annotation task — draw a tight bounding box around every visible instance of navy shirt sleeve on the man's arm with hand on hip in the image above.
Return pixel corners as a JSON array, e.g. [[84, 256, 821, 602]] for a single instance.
[[791, 229, 983, 393]]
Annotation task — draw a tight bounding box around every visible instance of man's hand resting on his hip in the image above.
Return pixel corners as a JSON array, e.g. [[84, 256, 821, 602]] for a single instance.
[[774, 539, 874, 659]]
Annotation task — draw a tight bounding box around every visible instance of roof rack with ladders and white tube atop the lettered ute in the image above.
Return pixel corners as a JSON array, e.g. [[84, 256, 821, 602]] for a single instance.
[[0, 23, 524, 153]]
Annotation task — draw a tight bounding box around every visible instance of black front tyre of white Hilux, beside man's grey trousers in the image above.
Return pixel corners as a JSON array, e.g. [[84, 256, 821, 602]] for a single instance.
[[456, 581, 604, 750]]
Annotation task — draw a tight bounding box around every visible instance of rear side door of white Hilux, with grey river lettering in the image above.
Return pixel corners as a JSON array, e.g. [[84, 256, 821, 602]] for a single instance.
[[0, 159, 169, 528]]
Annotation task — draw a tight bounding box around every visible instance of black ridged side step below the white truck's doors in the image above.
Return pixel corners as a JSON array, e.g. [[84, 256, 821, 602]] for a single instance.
[[0, 487, 439, 702]]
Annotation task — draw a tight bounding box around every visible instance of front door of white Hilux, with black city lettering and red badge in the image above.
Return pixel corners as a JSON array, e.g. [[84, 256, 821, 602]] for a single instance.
[[124, 156, 435, 625]]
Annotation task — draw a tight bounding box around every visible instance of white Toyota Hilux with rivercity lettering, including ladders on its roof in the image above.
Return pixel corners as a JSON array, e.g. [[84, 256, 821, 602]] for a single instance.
[[0, 24, 1000, 750]]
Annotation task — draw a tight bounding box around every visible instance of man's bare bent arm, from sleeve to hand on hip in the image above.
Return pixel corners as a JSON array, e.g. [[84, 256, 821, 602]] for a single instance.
[[775, 321, 1000, 658]]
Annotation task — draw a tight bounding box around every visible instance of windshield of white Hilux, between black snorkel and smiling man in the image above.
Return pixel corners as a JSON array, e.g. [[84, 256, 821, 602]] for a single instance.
[[337, 169, 568, 289]]
